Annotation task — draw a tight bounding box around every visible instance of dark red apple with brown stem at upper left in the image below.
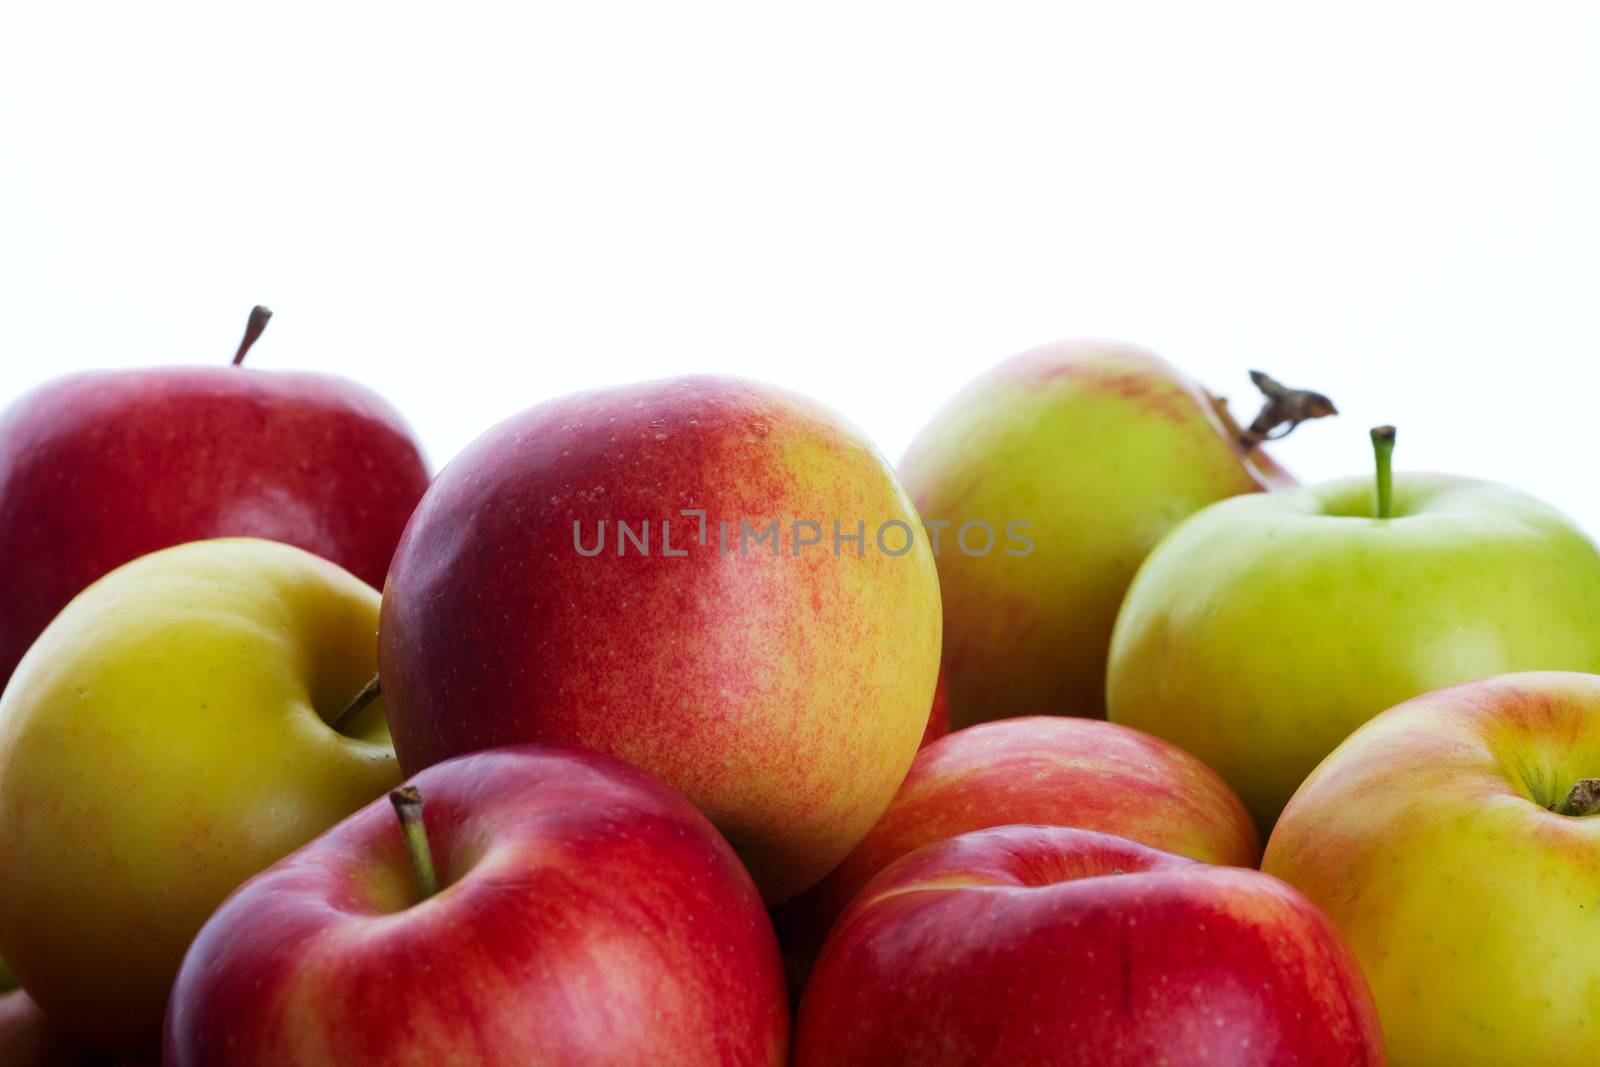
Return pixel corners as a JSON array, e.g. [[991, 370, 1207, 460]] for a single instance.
[[0, 309, 427, 685]]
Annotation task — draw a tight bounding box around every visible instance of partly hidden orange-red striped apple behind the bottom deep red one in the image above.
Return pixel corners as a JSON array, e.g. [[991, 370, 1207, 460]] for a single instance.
[[784, 715, 1261, 971]]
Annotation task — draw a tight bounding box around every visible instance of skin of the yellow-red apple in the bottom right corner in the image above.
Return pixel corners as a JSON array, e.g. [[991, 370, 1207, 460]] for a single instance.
[[1262, 672, 1600, 1067]]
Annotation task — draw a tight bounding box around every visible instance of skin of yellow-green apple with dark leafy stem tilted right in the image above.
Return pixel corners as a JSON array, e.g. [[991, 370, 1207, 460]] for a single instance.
[[899, 341, 1291, 728]]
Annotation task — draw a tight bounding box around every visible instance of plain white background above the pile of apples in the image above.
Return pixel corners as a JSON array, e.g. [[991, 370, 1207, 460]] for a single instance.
[[0, 0, 1600, 531]]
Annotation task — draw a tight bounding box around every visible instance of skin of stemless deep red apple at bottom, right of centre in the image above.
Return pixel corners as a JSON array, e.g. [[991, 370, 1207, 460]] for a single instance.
[[795, 825, 1384, 1067]]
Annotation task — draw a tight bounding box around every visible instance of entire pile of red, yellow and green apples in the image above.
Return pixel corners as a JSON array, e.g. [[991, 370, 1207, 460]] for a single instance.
[[0, 319, 1600, 1067]]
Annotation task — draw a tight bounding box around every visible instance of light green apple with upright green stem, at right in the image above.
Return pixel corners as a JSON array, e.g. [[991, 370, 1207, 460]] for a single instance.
[[1107, 427, 1600, 830]]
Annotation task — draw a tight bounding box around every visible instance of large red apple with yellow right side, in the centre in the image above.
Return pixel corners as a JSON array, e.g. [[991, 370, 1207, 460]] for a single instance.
[[379, 376, 939, 902]]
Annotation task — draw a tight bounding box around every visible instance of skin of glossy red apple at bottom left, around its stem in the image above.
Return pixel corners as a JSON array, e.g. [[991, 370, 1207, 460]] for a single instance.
[[163, 745, 789, 1067]]
